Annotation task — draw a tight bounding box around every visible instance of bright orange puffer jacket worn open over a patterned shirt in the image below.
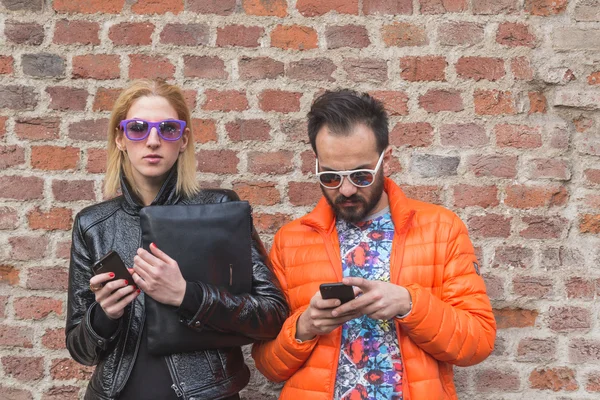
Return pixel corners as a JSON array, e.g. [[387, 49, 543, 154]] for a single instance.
[[252, 179, 496, 400]]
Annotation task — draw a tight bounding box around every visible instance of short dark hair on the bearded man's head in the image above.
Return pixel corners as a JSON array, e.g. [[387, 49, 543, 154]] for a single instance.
[[307, 89, 389, 154]]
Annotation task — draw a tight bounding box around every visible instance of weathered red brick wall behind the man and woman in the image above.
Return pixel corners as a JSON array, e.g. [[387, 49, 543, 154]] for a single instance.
[[0, 0, 600, 400]]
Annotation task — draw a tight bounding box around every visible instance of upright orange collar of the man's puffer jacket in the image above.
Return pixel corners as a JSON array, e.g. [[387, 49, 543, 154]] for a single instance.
[[300, 178, 414, 234]]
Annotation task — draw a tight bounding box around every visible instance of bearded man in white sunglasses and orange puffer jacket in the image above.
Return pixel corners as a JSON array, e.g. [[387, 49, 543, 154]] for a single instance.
[[252, 90, 496, 400]]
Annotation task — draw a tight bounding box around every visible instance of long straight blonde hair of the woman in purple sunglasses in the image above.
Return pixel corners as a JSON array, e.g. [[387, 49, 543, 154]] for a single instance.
[[104, 79, 199, 197]]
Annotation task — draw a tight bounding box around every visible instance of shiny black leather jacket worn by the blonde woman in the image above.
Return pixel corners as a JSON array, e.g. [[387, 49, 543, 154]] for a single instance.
[[66, 168, 288, 400]]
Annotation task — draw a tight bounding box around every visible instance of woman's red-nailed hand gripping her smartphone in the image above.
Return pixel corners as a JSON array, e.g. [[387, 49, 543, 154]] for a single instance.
[[90, 272, 140, 319]]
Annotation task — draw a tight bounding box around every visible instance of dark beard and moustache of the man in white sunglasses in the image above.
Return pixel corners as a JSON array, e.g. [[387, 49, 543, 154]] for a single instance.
[[319, 174, 383, 223]]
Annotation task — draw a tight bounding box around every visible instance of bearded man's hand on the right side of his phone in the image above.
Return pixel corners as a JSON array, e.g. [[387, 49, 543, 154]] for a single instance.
[[331, 277, 411, 320]]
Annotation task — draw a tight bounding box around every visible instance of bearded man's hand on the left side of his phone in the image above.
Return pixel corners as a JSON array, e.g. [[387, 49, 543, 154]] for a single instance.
[[296, 291, 360, 341]]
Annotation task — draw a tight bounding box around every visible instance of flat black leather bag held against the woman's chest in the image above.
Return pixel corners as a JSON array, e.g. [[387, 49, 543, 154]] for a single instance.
[[140, 201, 252, 355]]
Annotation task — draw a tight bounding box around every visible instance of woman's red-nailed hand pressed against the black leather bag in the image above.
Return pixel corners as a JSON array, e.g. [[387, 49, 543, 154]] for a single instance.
[[133, 243, 187, 307]]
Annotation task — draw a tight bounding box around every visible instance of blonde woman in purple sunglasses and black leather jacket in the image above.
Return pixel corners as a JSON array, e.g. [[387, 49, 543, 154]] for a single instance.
[[66, 80, 287, 400]]
